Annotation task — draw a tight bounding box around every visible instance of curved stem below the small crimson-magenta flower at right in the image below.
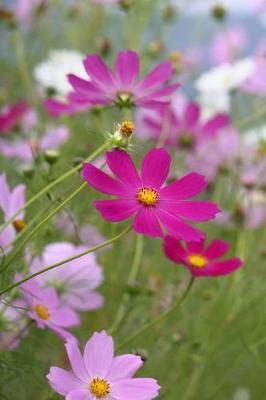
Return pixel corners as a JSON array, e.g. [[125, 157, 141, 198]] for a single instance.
[[118, 276, 194, 348]]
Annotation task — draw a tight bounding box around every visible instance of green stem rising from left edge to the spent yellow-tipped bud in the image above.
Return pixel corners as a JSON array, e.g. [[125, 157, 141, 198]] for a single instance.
[[0, 143, 108, 233]]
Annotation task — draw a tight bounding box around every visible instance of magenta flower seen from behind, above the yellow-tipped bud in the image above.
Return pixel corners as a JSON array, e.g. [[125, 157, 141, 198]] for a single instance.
[[46, 50, 179, 115]]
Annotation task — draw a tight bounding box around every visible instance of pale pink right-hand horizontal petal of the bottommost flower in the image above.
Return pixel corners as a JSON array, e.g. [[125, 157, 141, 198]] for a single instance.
[[112, 378, 160, 400]]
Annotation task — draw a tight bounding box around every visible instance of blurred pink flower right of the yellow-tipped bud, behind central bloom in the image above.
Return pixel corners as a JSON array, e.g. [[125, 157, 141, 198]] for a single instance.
[[136, 96, 230, 149]]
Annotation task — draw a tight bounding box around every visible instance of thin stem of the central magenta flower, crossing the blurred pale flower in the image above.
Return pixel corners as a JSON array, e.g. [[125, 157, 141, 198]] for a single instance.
[[0, 225, 132, 296]]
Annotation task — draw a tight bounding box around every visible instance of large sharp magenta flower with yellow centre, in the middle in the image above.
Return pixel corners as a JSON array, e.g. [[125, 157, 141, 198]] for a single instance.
[[83, 149, 219, 241]]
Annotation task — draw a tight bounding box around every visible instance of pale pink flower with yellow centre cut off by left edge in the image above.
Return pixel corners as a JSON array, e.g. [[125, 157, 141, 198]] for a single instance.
[[0, 174, 26, 253]]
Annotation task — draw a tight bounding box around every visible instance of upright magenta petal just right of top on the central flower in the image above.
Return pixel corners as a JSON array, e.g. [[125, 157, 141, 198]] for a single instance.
[[141, 149, 171, 189]]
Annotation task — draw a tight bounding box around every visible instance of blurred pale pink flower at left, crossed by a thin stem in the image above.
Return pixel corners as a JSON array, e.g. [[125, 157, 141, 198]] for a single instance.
[[30, 242, 104, 311]]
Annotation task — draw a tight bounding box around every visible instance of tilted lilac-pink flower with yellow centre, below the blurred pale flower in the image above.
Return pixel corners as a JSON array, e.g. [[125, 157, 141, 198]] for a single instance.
[[20, 279, 80, 339]]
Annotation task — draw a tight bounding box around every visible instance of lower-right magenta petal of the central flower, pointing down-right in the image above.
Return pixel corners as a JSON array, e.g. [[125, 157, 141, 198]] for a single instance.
[[156, 208, 204, 242]]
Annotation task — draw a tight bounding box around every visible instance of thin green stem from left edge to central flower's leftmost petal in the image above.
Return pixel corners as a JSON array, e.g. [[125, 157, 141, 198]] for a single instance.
[[0, 182, 87, 272]]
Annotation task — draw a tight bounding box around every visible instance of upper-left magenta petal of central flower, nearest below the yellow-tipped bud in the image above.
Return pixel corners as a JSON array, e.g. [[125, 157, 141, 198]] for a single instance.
[[106, 149, 141, 189]]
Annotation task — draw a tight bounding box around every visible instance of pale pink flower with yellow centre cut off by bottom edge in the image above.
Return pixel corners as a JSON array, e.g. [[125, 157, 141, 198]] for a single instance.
[[47, 331, 160, 400]]
